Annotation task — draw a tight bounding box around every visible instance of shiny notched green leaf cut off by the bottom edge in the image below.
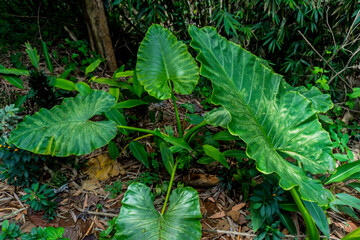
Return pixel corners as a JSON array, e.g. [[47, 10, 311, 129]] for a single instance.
[[115, 183, 201, 240]]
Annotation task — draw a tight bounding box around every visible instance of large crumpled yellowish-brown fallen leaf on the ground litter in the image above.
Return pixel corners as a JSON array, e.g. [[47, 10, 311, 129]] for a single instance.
[[84, 154, 125, 181]]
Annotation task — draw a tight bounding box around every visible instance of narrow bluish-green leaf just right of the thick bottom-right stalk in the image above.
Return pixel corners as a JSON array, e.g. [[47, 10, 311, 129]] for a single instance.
[[303, 201, 330, 238]]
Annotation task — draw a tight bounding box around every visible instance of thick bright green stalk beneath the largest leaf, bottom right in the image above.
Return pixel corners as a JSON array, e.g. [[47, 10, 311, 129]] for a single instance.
[[290, 188, 320, 240]]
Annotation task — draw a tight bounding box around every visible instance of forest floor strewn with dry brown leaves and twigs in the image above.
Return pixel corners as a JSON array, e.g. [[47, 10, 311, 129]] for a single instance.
[[0, 47, 360, 240]]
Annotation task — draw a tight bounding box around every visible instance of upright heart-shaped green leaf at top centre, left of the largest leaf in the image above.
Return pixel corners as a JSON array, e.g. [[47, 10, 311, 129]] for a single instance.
[[136, 25, 199, 100]]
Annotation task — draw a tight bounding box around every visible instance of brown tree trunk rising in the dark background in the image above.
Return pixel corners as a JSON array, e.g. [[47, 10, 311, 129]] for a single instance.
[[84, 0, 117, 72]]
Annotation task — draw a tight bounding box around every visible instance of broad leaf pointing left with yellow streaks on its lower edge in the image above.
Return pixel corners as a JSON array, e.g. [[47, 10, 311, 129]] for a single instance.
[[9, 91, 116, 157]]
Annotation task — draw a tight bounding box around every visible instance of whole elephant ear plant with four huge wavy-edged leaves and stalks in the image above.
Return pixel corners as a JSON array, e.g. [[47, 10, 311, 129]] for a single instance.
[[9, 25, 348, 240]]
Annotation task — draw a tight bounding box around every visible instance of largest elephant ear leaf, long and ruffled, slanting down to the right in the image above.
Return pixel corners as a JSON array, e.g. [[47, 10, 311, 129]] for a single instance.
[[190, 26, 335, 206]]
